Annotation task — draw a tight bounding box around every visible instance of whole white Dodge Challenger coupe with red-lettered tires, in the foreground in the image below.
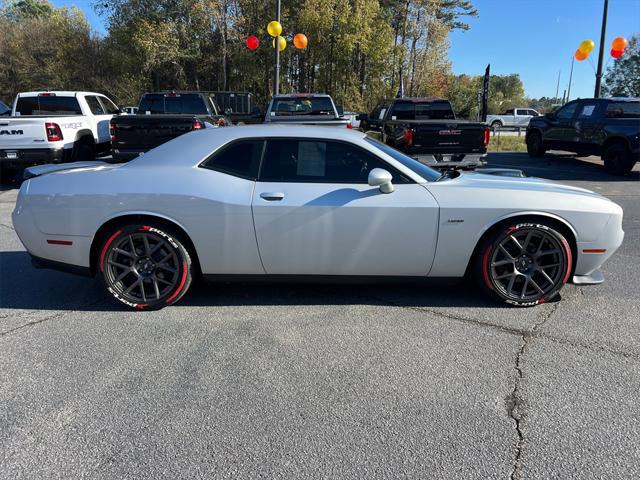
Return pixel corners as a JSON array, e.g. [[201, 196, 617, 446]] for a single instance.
[[13, 125, 624, 309]]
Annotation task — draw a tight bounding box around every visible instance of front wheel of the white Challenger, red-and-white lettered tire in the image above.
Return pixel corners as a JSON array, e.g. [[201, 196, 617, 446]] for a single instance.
[[474, 223, 573, 307]]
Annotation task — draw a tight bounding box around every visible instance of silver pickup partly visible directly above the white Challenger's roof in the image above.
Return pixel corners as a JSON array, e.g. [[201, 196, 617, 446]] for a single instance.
[[264, 93, 353, 128]]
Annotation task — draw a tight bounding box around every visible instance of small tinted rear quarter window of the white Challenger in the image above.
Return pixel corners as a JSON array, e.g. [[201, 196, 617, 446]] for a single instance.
[[200, 140, 264, 179]]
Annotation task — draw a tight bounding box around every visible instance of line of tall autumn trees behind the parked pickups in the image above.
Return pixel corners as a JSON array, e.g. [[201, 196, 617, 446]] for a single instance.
[[0, 0, 636, 118]]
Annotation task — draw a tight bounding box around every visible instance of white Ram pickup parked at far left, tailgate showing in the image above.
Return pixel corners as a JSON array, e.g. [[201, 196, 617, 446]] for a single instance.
[[0, 91, 120, 169]]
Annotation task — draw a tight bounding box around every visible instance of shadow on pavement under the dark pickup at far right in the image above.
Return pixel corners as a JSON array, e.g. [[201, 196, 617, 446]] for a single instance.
[[487, 152, 640, 182]]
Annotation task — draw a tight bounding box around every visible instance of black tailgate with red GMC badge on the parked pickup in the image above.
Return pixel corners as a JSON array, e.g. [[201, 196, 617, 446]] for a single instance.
[[410, 120, 486, 154]]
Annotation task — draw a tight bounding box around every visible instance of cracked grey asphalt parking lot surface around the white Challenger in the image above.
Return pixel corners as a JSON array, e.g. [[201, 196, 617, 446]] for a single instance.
[[0, 153, 640, 479]]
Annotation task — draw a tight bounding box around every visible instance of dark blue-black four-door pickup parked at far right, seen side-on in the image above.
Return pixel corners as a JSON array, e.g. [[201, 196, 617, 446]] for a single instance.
[[526, 98, 640, 174]]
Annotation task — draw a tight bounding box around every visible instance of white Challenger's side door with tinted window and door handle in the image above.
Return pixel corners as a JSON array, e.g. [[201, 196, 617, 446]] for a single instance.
[[252, 138, 438, 276]]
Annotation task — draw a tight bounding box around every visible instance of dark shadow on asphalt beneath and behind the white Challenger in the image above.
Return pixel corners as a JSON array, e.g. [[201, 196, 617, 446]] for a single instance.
[[0, 251, 500, 311]]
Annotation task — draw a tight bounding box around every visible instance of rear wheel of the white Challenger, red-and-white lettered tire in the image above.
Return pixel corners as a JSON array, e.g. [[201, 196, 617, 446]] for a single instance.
[[99, 225, 193, 310]]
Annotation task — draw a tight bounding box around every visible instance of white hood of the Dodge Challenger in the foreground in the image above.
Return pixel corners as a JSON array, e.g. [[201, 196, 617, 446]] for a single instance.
[[451, 172, 605, 198]]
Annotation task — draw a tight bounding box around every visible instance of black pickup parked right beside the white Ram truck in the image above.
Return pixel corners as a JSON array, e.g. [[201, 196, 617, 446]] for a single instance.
[[110, 92, 231, 161]]
